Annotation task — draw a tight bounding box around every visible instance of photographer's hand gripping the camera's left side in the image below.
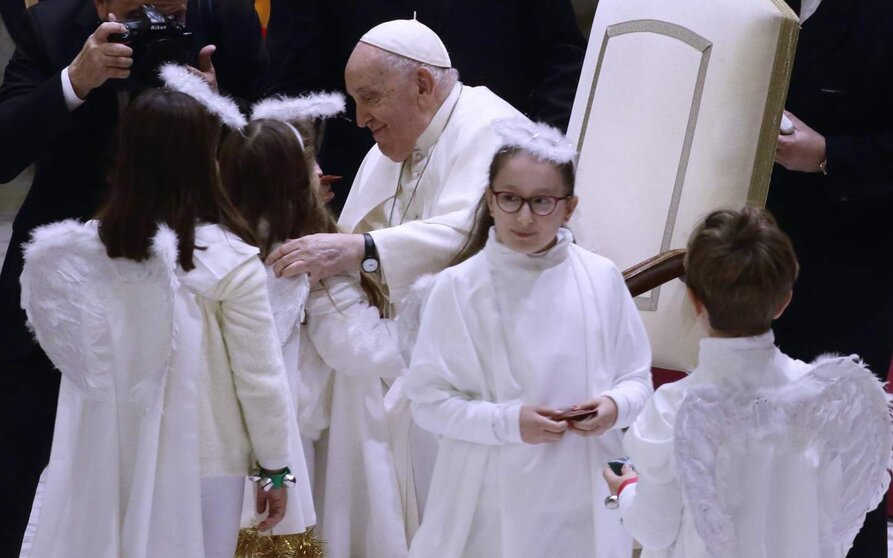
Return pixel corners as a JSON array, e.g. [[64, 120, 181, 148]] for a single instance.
[[68, 21, 133, 99]]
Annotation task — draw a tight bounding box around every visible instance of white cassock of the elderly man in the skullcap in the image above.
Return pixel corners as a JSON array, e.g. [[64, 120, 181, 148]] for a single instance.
[[338, 84, 523, 302]]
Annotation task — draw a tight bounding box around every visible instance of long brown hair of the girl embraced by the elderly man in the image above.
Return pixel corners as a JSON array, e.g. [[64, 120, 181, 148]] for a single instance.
[[220, 120, 386, 313]]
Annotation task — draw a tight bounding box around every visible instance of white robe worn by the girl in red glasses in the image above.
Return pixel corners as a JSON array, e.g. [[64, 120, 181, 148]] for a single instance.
[[407, 229, 652, 558]]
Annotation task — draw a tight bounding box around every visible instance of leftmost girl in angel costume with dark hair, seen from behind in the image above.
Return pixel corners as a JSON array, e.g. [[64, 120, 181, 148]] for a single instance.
[[21, 69, 315, 558]]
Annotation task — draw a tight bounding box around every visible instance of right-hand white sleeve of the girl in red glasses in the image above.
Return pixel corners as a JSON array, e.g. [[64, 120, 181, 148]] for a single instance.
[[602, 269, 654, 429]]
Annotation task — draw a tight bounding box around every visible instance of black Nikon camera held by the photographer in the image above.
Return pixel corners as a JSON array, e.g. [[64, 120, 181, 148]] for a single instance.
[[109, 5, 192, 90]]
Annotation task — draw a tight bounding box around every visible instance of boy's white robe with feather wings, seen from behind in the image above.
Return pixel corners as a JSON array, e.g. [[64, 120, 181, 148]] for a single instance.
[[620, 332, 893, 558]]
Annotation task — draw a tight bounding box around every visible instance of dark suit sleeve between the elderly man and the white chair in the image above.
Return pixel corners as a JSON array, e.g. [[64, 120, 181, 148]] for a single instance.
[[522, 0, 586, 130]]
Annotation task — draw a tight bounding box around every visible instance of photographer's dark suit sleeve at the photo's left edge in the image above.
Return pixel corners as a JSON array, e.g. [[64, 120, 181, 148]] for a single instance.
[[0, 9, 71, 183]]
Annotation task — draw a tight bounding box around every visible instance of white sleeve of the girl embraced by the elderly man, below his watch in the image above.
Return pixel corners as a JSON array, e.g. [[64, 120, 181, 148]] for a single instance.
[[307, 276, 406, 378]]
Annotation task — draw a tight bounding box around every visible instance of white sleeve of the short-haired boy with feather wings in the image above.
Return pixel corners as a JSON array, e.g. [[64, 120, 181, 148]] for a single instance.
[[619, 390, 682, 550]]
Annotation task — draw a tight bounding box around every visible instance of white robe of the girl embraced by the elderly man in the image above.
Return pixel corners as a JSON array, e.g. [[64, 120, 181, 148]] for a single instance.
[[301, 275, 408, 558]]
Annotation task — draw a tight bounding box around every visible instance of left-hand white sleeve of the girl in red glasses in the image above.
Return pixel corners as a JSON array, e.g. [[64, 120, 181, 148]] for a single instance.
[[407, 276, 521, 444]]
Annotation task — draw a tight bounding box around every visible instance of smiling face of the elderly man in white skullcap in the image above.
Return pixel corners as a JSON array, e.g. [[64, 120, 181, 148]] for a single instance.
[[344, 43, 431, 162]]
